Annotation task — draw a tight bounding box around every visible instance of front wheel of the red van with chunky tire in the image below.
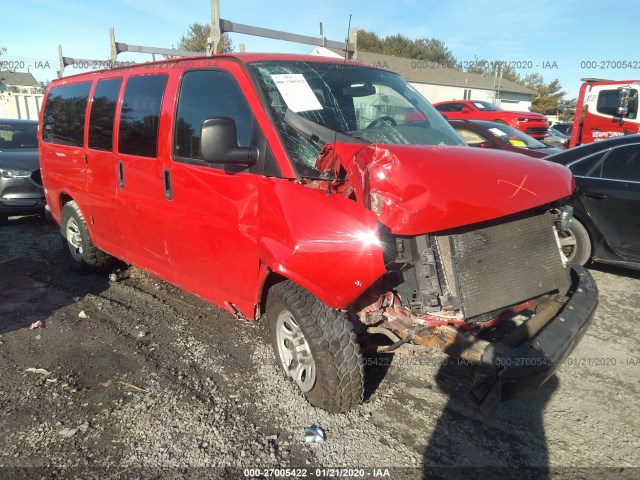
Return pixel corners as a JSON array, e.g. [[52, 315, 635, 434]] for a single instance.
[[267, 281, 364, 413]]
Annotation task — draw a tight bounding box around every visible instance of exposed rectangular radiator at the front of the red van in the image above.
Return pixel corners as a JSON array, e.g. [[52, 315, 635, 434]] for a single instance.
[[433, 213, 569, 319]]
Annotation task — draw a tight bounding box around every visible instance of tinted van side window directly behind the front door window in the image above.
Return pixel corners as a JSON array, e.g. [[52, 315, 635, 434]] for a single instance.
[[118, 75, 167, 157]]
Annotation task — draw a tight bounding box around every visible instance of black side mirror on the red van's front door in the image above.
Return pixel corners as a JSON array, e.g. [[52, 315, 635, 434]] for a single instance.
[[200, 117, 258, 165]]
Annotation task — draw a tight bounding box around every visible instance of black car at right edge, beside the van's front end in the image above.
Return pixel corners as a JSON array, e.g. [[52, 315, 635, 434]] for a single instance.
[[545, 135, 640, 269]]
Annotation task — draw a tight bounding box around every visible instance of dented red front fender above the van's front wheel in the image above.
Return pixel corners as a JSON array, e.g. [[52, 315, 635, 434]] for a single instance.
[[258, 180, 385, 308]]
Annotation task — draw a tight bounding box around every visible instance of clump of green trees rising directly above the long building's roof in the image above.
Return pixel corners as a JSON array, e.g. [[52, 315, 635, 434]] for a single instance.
[[357, 30, 456, 66]]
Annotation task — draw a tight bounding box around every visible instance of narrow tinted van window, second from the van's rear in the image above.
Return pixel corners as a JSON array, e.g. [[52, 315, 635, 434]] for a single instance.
[[89, 78, 122, 152]]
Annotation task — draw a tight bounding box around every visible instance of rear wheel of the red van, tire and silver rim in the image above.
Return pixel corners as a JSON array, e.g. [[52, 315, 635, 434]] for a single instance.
[[60, 201, 113, 273]]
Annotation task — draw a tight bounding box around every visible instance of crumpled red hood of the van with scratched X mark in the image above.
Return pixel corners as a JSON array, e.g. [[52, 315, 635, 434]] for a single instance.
[[316, 142, 574, 235]]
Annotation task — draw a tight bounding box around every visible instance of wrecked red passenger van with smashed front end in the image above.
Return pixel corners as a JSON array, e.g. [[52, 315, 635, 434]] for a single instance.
[[39, 54, 597, 412]]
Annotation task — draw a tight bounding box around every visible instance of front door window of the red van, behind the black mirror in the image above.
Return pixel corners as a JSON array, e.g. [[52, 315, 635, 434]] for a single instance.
[[173, 70, 255, 159]]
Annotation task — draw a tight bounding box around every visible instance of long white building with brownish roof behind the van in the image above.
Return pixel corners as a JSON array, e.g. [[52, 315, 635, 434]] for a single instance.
[[311, 47, 536, 112]]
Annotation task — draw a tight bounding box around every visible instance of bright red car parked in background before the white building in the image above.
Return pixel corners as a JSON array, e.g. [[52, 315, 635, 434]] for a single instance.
[[433, 100, 549, 140]]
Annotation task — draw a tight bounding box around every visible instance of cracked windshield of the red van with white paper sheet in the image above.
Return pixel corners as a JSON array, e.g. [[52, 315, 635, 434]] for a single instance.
[[251, 61, 464, 175]]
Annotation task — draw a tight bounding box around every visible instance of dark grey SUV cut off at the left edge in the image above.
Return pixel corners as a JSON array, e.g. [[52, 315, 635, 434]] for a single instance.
[[0, 120, 45, 223]]
